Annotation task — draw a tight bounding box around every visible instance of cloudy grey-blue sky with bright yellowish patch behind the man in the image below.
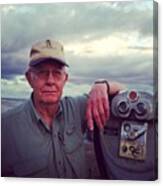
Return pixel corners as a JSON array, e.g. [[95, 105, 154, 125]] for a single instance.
[[1, 0, 155, 97]]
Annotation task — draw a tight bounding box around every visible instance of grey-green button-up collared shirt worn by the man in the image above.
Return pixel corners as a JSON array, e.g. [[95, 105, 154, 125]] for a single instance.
[[1, 96, 88, 178]]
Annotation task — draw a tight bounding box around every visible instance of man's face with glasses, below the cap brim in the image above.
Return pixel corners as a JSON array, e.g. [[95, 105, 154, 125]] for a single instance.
[[26, 62, 68, 104]]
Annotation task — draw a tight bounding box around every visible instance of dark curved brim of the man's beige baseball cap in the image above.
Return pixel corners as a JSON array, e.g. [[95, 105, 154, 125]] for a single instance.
[[29, 57, 69, 67]]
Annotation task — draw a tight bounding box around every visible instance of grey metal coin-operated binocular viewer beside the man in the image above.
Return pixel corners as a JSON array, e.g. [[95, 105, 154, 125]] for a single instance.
[[94, 90, 157, 180]]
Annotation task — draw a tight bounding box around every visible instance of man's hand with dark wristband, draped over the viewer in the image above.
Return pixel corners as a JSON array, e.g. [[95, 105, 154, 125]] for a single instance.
[[86, 83, 123, 130]]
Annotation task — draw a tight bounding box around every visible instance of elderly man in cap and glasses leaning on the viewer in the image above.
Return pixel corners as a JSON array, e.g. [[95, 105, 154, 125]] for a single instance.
[[1, 40, 120, 178]]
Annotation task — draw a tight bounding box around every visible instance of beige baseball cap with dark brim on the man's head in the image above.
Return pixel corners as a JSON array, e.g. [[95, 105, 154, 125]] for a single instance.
[[29, 39, 69, 67]]
